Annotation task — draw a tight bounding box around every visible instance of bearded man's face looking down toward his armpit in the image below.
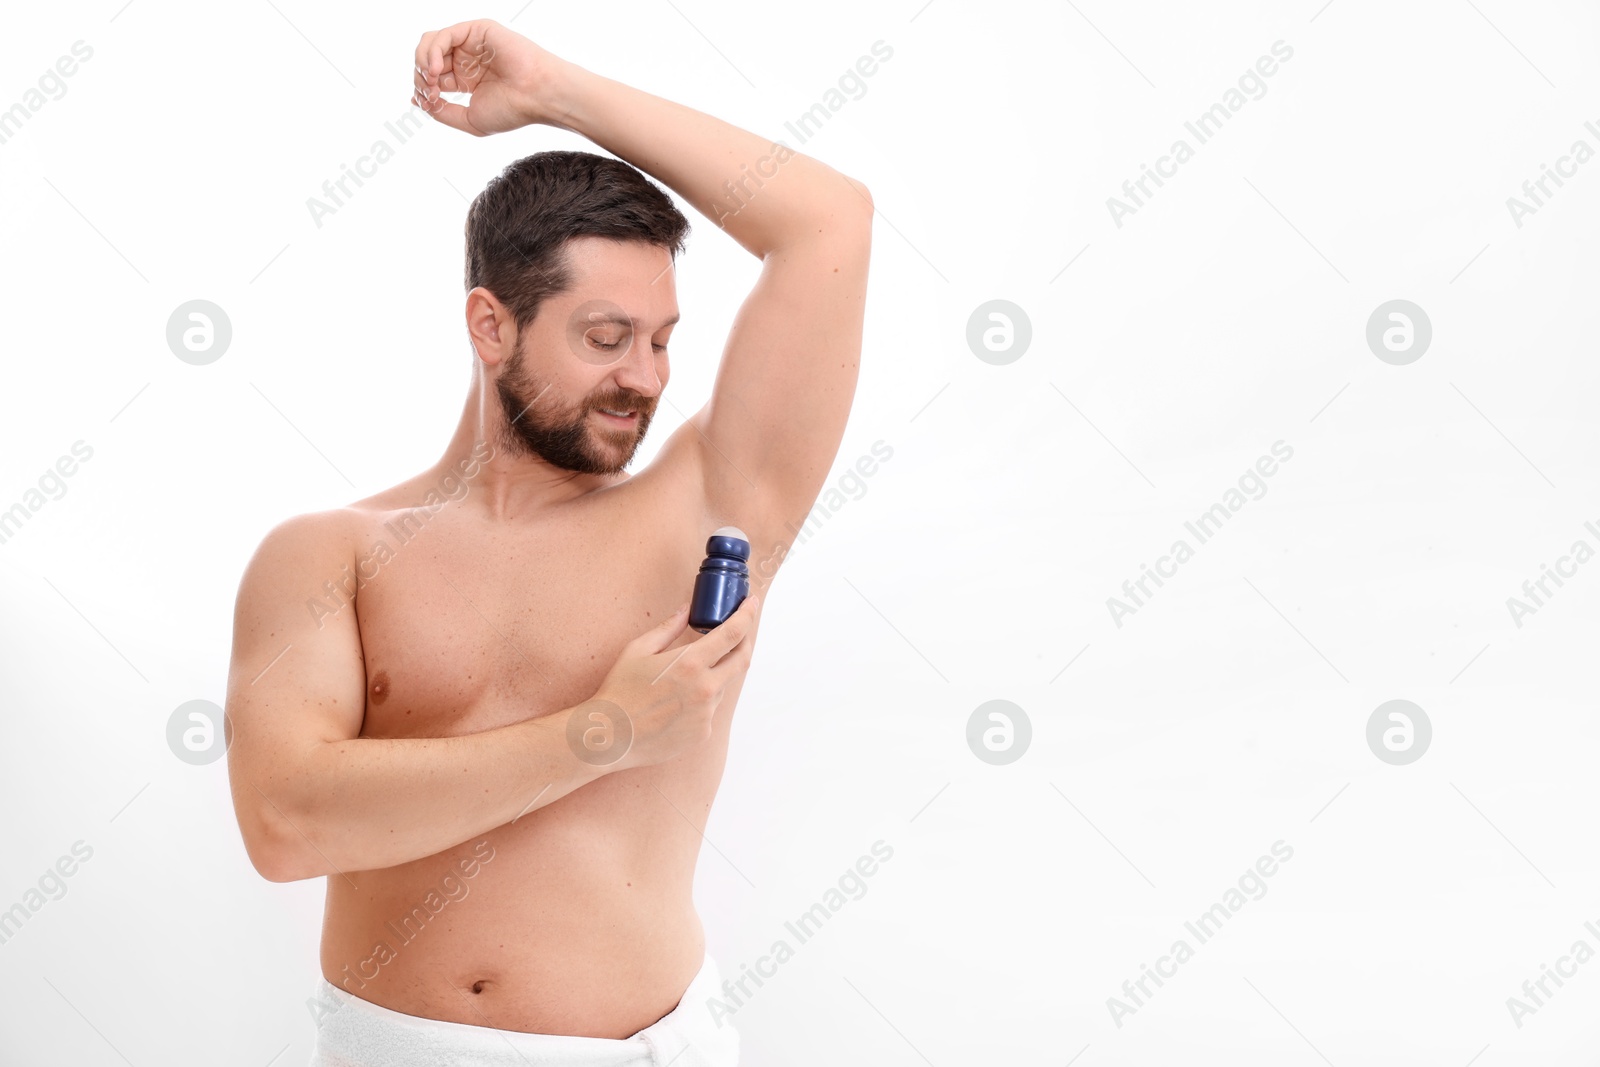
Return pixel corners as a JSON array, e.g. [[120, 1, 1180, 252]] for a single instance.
[[494, 237, 678, 475]]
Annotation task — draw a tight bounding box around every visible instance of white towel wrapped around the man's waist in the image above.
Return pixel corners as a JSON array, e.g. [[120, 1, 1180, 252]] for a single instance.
[[310, 952, 739, 1067]]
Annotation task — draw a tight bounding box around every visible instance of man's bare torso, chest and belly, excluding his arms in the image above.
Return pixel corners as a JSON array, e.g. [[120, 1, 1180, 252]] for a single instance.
[[322, 456, 755, 1037]]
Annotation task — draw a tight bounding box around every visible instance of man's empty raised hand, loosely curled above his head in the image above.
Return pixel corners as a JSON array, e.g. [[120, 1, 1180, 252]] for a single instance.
[[411, 19, 562, 138]]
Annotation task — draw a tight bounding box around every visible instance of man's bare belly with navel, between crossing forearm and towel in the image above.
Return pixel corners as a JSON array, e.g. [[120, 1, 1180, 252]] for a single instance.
[[322, 755, 731, 1038]]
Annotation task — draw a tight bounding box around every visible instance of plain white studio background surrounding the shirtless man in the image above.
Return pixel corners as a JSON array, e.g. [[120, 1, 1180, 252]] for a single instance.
[[0, 0, 1600, 1067]]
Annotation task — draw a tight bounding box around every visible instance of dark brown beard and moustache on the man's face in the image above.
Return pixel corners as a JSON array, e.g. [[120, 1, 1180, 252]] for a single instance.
[[494, 338, 656, 475]]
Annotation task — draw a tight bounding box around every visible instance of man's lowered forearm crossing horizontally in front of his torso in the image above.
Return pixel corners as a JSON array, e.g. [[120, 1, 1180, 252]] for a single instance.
[[245, 705, 610, 881]]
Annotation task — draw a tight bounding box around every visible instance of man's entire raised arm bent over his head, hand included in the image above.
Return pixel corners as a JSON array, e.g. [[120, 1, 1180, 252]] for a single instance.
[[416, 19, 874, 556]]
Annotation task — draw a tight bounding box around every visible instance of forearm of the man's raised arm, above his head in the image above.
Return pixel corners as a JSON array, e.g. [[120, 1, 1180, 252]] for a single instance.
[[549, 61, 870, 258]]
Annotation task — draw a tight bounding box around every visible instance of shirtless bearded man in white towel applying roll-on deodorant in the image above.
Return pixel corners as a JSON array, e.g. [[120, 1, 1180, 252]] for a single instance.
[[227, 19, 874, 1067]]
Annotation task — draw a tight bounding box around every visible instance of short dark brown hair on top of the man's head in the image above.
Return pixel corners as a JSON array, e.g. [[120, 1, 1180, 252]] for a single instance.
[[466, 150, 690, 331]]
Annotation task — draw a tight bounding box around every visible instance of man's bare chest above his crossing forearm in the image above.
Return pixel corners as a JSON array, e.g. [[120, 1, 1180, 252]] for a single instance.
[[355, 489, 709, 737]]
